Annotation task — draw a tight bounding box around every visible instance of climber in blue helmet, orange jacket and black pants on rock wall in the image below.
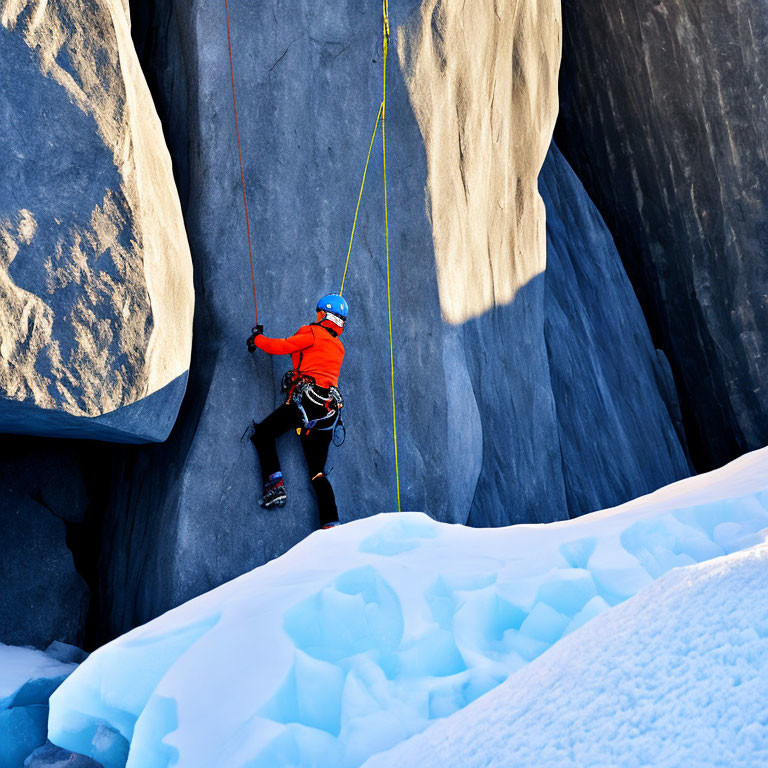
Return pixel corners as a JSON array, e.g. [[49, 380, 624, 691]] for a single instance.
[[248, 293, 349, 528]]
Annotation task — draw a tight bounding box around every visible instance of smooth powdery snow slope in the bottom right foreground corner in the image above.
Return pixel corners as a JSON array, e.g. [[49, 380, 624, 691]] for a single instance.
[[365, 544, 768, 768]]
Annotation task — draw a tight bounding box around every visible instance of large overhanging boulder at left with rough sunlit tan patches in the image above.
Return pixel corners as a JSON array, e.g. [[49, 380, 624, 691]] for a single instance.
[[0, 0, 194, 442]]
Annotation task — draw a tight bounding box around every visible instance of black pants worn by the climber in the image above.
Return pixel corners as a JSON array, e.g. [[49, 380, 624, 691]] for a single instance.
[[251, 403, 339, 525]]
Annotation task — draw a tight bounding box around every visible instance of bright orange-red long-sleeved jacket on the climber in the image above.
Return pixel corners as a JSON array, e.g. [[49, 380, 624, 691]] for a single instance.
[[253, 323, 344, 387]]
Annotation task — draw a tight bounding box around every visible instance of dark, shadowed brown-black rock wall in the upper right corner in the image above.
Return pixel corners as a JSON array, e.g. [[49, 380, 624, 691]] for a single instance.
[[557, 0, 768, 469]]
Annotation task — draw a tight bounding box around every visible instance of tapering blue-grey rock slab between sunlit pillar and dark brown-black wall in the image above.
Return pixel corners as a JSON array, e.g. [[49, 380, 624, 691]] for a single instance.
[[539, 144, 689, 516]]
